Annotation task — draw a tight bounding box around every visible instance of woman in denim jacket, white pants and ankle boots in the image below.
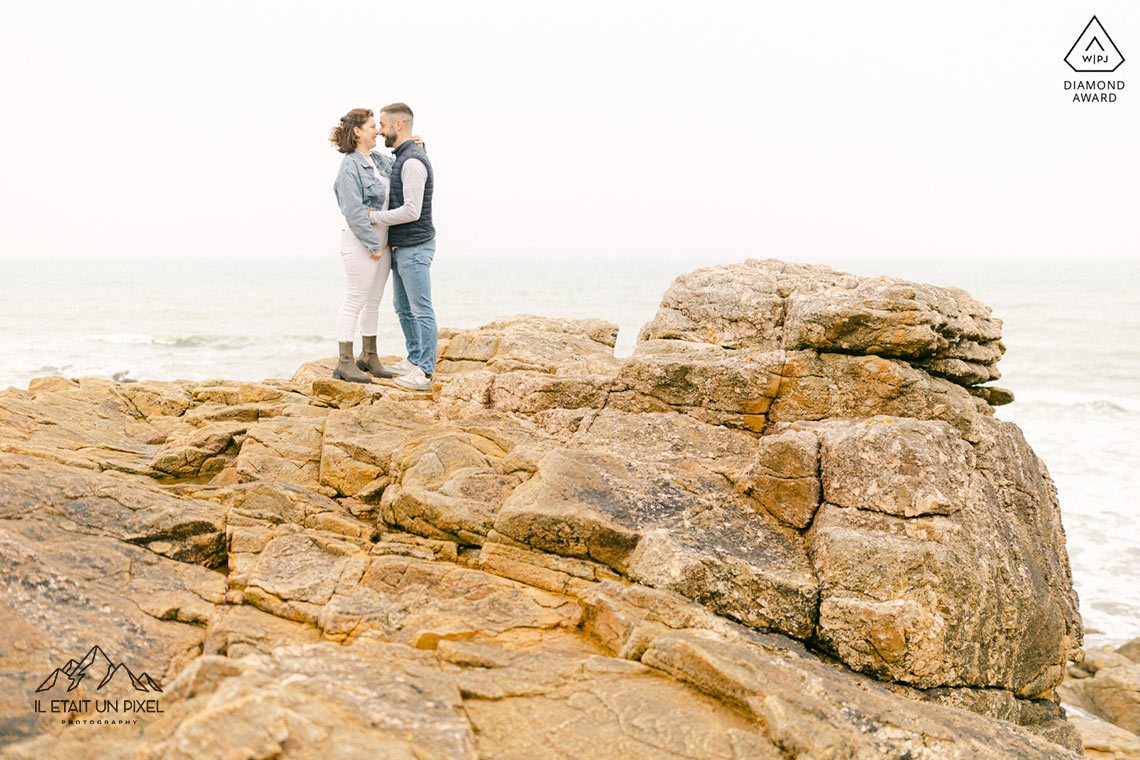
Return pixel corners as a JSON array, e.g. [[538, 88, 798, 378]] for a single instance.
[[328, 108, 401, 383]]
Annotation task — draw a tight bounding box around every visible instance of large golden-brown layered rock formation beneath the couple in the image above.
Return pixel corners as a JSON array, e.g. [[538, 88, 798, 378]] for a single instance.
[[0, 260, 1082, 760]]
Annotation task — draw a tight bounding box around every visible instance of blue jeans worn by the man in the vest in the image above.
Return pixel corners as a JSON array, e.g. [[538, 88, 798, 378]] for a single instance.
[[392, 240, 439, 377]]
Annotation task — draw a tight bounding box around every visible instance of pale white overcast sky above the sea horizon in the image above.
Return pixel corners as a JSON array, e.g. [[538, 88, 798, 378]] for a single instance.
[[0, 0, 1140, 260]]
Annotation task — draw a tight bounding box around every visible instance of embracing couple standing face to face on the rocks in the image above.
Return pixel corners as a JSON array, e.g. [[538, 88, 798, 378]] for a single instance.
[[329, 103, 439, 391]]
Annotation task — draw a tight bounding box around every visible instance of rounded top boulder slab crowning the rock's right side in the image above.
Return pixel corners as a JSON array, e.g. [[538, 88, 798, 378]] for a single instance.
[[640, 260, 1005, 385]]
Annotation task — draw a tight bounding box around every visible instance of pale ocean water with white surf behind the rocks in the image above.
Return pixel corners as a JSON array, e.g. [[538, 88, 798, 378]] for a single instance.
[[0, 251, 1140, 645]]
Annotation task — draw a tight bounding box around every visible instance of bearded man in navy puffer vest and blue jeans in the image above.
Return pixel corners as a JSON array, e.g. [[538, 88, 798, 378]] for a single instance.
[[369, 103, 439, 391]]
